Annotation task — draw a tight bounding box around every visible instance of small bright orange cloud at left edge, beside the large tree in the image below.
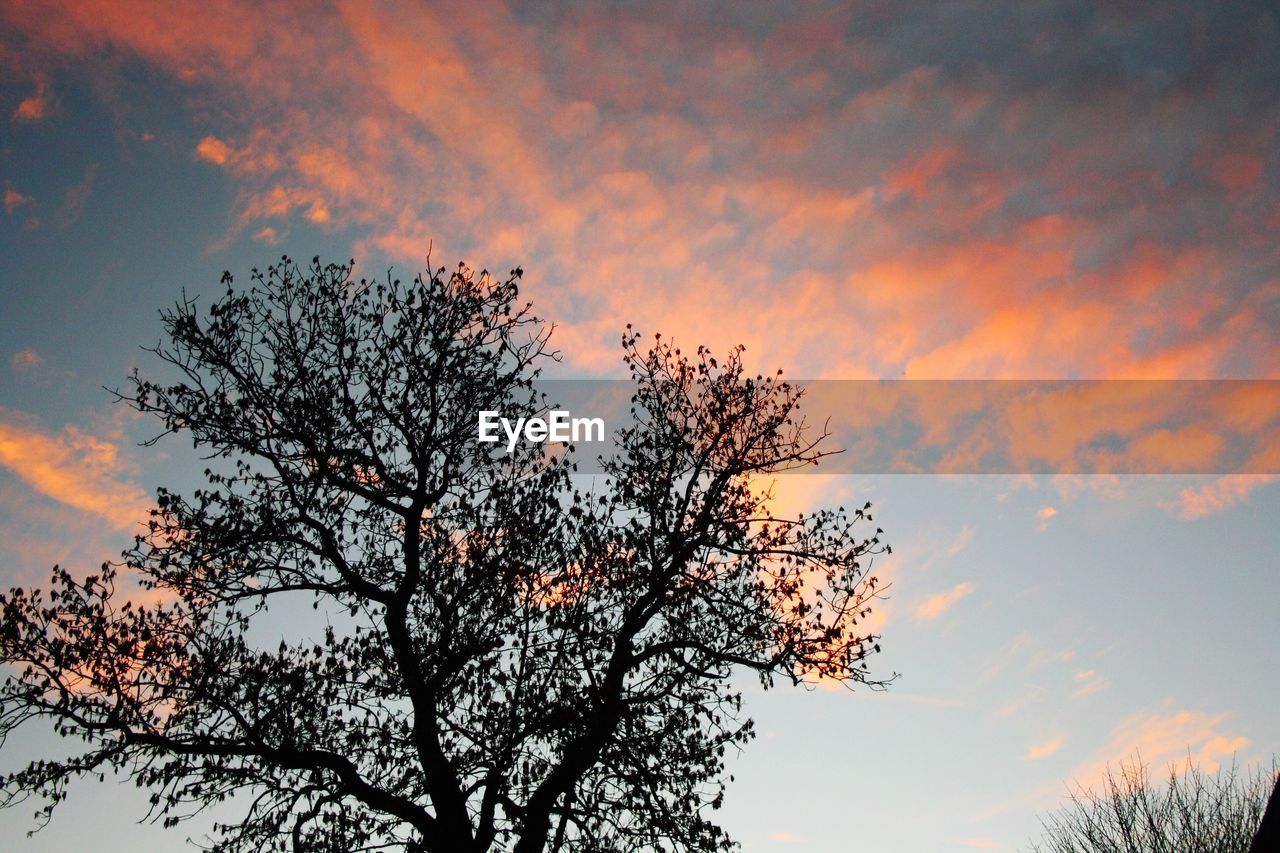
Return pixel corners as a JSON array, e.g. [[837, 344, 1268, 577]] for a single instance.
[[0, 409, 151, 533]]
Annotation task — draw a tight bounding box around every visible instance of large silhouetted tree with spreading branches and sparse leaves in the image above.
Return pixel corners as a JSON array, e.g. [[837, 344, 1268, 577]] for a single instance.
[[0, 259, 887, 853]]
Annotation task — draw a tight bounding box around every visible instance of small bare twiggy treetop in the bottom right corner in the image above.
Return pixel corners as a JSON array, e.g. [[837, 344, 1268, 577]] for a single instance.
[[1032, 758, 1277, 853]]
